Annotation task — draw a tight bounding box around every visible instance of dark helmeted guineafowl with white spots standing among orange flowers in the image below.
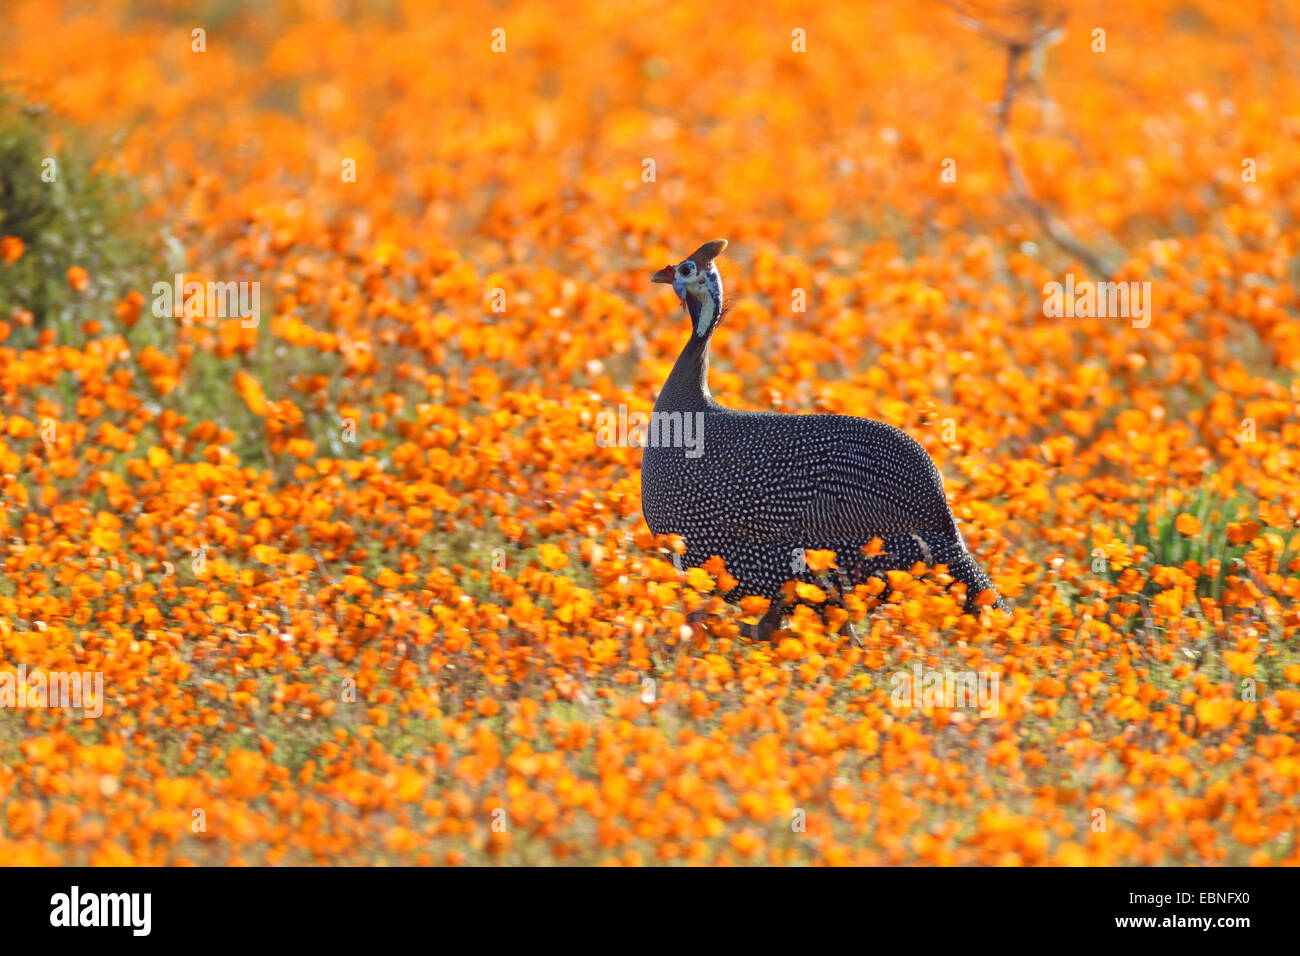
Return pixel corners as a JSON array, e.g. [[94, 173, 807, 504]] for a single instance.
[[641, 239, 1006, 637]]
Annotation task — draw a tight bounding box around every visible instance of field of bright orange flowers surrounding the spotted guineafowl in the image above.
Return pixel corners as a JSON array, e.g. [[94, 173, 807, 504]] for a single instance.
[[0, 0, 1300, 866]]
